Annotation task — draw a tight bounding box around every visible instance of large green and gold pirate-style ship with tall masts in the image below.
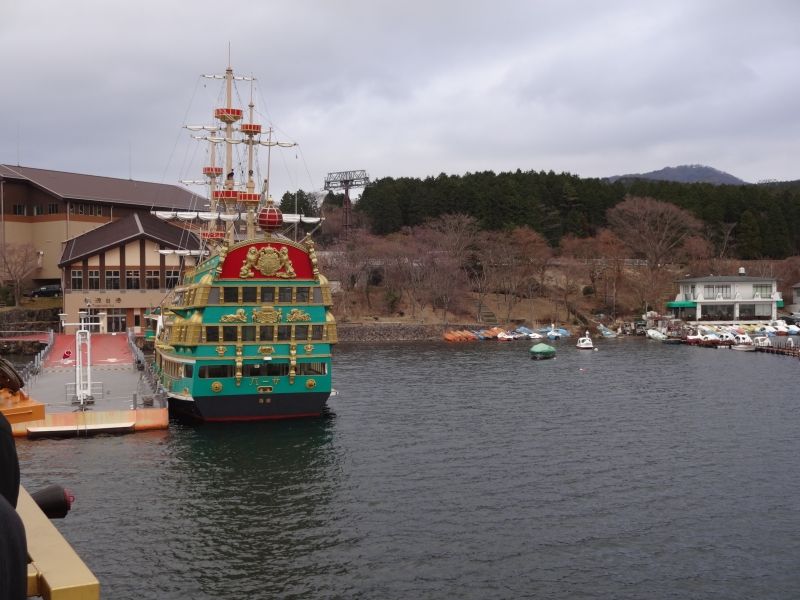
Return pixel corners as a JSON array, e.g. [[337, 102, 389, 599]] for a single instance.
[[154, 62, 337, 421]]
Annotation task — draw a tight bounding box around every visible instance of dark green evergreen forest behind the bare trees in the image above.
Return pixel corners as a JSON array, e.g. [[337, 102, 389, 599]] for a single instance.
[[355, 171, 800, 259]]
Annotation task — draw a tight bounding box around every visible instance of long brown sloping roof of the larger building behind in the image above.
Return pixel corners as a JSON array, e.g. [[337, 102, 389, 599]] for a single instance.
[[0, 165, 208, 210]]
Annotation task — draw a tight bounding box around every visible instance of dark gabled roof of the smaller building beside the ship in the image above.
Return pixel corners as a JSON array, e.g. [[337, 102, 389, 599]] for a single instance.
[[58, 212, 200, 267]]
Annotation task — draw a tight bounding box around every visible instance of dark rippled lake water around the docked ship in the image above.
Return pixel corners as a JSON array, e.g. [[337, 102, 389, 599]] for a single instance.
[[18, 338, 800, 600]]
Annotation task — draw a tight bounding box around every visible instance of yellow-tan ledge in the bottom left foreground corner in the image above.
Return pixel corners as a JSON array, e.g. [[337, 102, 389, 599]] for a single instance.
[[17, 486, 100, 600]]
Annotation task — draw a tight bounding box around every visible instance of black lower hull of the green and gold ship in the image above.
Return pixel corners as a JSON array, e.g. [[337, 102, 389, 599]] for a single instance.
[[169, 392, 330, 422]]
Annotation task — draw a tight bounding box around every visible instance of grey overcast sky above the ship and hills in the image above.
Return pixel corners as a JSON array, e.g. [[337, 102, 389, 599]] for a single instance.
[[0, 0, 800, 197]]
